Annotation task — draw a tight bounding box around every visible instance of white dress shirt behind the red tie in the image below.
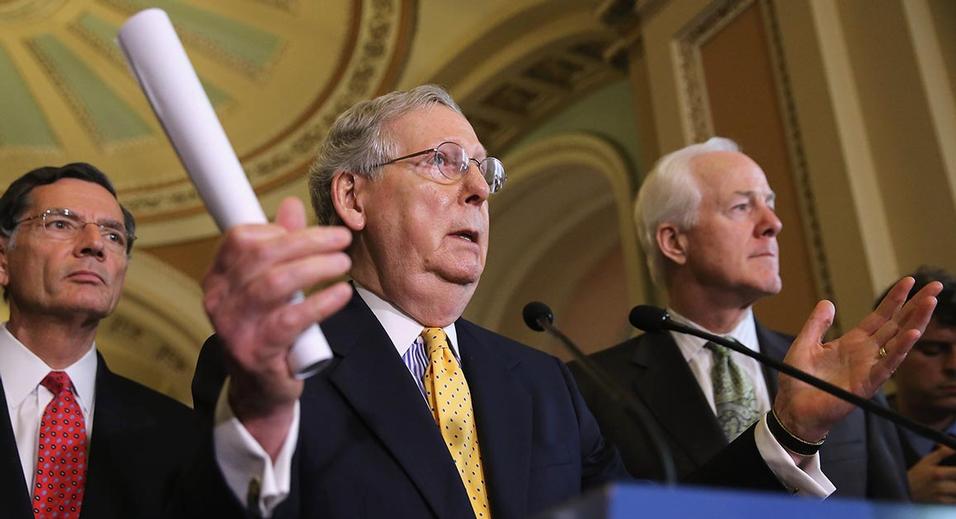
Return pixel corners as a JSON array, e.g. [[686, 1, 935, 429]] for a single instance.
[[0, 323, 97, 495]]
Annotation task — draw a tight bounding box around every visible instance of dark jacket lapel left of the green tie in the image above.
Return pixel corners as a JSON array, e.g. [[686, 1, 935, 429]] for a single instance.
[[632, 332, 727, 466]]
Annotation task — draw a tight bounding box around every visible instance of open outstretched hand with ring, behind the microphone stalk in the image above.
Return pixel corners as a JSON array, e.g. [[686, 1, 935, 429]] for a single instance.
[[773, 277, 942, 442]]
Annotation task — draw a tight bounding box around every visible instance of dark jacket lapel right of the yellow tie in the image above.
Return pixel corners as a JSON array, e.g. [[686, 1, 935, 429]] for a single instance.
[[456, 319, 532, 518]]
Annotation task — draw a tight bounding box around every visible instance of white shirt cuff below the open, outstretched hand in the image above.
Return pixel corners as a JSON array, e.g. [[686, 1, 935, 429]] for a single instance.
[[754, 414, 836, 499]]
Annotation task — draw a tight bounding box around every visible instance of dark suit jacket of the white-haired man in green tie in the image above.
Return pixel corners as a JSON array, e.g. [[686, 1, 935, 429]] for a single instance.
[[571, 324, 908, 499]]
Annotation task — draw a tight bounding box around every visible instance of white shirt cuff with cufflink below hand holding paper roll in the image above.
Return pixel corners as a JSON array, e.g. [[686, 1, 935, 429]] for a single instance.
[[213, 378, 299, 517]]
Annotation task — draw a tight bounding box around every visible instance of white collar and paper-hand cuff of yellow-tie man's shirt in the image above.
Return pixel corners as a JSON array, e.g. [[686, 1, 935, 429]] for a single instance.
[[213, 284, 461, 517]]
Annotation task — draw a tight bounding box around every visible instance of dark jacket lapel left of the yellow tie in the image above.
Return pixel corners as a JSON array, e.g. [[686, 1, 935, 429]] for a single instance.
[[322, 294, 471, 517]]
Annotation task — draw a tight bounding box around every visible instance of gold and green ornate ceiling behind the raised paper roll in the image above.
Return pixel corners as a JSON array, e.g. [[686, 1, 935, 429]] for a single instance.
[[0, 0, 414, 242]]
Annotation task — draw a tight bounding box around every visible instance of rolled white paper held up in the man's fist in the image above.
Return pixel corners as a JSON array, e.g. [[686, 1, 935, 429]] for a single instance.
[[118, 9, 332, 378]]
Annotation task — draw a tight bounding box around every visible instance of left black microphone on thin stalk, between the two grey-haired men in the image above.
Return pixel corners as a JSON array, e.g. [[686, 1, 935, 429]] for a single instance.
[[521, 301, 677, 485]]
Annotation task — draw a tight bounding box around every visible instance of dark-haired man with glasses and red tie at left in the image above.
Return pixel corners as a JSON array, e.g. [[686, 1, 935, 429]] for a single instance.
[[0, 163, 198, 519]]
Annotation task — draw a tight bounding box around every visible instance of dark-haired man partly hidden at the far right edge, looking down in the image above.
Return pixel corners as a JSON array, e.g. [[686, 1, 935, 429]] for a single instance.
[[891, 267, 956, 504]]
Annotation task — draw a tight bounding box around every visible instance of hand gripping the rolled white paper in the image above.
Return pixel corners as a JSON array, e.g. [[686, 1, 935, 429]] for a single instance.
[[203, 198, 352, 456]]
